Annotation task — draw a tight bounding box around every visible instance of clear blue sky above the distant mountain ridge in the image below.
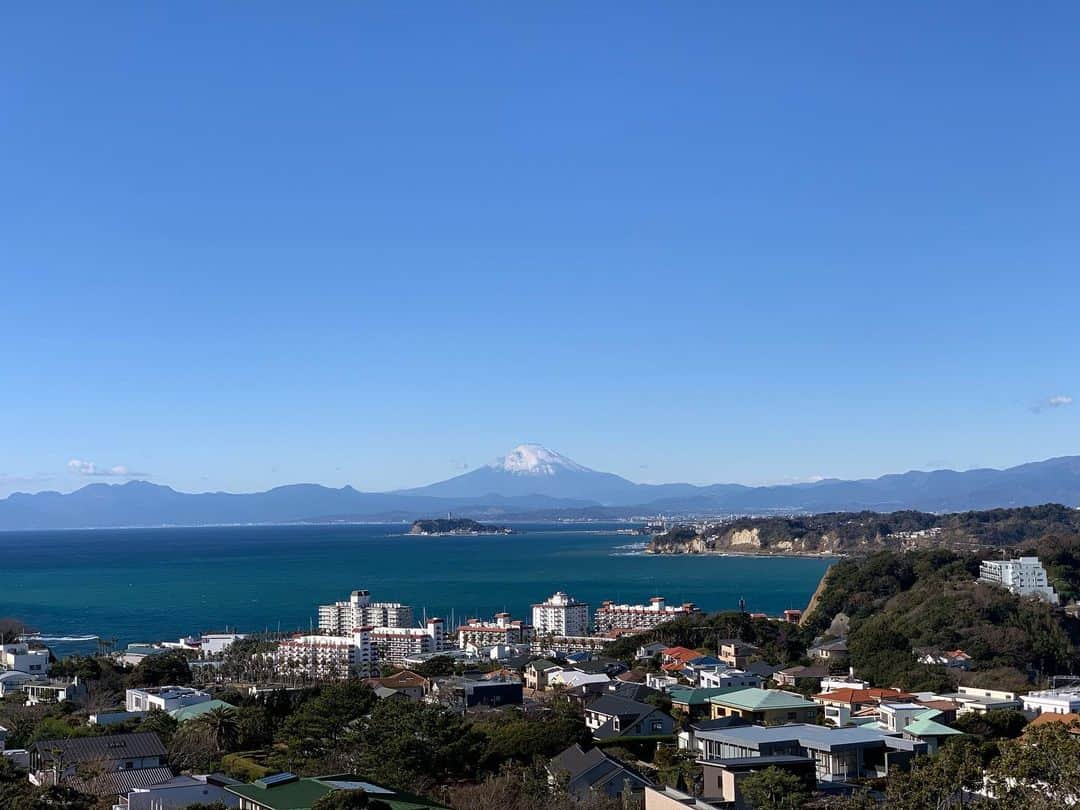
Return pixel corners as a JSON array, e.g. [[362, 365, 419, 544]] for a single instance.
[[0, 2, 1080, 495]]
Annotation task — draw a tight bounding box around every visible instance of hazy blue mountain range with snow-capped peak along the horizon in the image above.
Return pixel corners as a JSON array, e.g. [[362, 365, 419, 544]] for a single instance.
[[0, 444, 1080, 530]]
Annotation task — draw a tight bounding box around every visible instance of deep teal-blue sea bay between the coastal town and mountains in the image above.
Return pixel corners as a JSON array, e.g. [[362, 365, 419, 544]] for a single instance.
[[0, 524, 829, 654]]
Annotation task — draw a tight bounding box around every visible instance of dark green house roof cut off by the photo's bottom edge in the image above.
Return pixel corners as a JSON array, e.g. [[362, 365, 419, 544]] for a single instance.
[[225, 773, 445, 810]]
